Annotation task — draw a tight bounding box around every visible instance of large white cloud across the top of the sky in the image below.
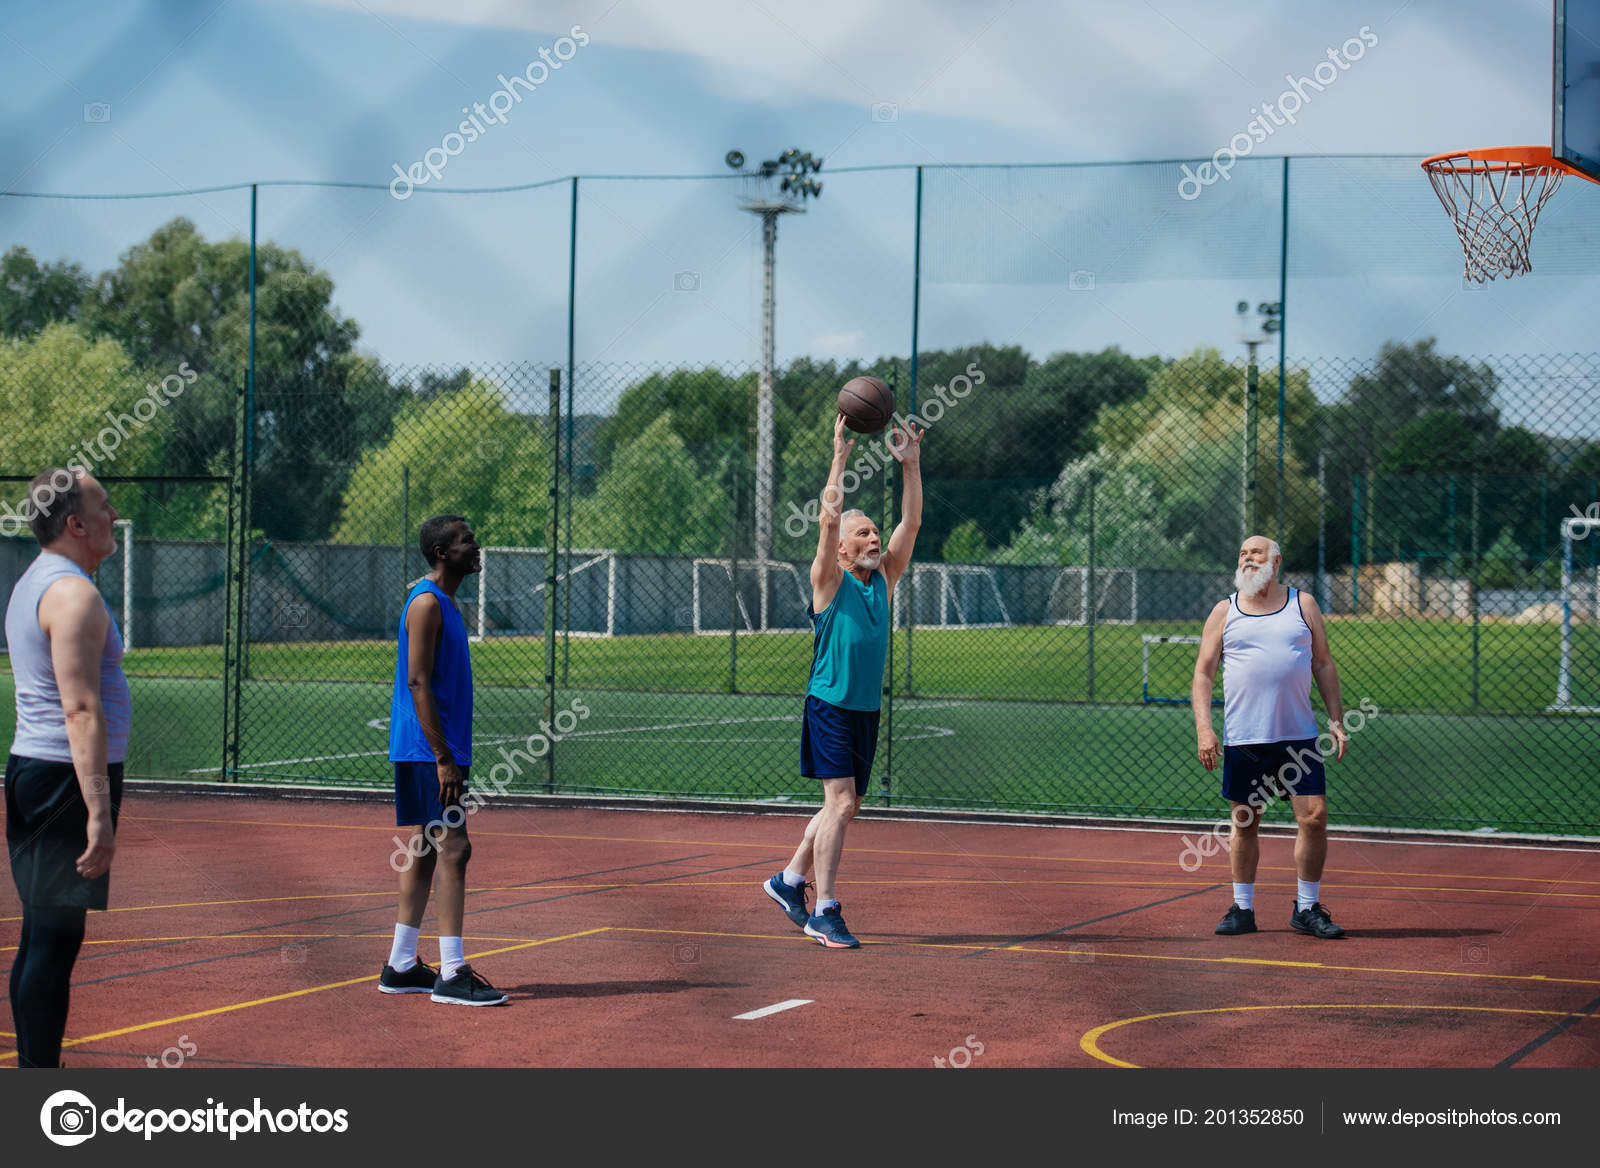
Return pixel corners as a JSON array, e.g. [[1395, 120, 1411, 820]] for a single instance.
[[288, 0, 1550, 162]]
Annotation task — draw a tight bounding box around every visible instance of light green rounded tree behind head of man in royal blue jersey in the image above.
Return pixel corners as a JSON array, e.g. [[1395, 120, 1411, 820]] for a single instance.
[[333, 381, 550, 547]]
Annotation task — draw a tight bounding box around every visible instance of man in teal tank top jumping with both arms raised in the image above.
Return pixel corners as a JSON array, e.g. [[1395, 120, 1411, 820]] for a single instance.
[[762, 414, 922, 949]]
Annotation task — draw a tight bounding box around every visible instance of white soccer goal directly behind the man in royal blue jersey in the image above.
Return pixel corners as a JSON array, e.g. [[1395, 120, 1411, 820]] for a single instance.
[[469, 547, 616, 642]]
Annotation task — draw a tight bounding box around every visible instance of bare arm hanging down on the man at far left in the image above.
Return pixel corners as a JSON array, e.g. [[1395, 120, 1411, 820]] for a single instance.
[[38, 578, 117, 880]]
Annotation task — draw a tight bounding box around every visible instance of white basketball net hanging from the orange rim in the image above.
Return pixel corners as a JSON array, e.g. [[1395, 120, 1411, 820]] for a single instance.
[[1427, 154, 1565, 283]]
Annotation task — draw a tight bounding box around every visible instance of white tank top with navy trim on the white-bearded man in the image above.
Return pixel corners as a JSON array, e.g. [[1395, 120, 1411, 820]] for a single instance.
[[1222, 587, 1317, 746]]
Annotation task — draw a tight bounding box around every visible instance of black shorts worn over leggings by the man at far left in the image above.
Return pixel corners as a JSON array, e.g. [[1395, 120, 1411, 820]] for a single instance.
[[5, 755, 122, 909]]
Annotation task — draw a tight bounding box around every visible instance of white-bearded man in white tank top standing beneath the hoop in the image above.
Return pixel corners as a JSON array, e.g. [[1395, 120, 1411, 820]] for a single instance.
[[1190, 536, 1347, 939]]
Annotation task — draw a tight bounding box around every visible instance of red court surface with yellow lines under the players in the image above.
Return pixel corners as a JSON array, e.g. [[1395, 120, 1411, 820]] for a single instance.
[[0, 794, 1600, 1070]]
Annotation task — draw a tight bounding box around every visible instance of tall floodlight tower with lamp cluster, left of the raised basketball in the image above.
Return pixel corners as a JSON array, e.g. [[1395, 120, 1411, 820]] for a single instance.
[[723, 146, 822, 629]]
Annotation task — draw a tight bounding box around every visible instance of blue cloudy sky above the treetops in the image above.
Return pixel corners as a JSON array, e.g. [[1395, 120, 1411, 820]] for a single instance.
[[0, 0, 1600, 409]]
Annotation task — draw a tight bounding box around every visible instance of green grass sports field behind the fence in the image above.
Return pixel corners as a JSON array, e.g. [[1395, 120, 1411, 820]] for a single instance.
[[0, 621, 1600, 834]]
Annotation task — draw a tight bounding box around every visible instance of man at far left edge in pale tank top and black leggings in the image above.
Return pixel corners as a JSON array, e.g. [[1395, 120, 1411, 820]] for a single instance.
[[5, 467, 131, 1067]]
